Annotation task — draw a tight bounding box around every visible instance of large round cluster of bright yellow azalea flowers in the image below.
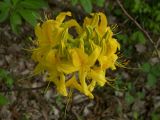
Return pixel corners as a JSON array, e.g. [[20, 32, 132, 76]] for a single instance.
[[32, 12, 120, 98]]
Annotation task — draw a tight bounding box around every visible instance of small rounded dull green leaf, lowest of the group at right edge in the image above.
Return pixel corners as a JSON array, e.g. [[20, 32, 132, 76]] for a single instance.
[[147, 74, 157, 87]]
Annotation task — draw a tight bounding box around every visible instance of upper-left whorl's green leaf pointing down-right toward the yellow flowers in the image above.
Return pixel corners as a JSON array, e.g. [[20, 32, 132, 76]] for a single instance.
[[19, 9, 39, 26]]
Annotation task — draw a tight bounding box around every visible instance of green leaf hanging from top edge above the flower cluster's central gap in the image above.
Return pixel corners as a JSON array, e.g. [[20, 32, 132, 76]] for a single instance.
[[80, 0, 92, 13]]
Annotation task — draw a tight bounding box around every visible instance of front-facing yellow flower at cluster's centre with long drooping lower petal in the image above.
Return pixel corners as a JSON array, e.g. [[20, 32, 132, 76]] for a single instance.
[[70, 44, 101, 98]]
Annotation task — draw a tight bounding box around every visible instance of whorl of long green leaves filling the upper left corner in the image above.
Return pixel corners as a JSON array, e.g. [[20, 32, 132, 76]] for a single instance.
[[0, 0, 48, 34]]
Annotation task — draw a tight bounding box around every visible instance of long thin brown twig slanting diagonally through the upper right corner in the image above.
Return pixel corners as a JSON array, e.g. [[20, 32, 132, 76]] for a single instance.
[[117, 0, 160, 60]]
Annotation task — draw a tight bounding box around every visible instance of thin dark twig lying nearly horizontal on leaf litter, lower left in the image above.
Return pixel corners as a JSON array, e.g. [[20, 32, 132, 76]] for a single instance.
[[0, 84, 47, 93]]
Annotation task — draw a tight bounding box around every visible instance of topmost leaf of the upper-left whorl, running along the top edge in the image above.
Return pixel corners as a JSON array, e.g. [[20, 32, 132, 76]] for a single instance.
[[20, 0, 48, 10]]
